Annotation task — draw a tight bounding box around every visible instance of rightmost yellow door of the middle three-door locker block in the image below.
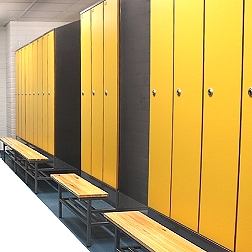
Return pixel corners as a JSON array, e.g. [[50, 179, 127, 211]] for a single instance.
[[103, 0, 119, 188]]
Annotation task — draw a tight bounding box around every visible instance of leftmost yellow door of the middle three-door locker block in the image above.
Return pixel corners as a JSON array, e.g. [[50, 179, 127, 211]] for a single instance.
[[81, 11, 92, 175]]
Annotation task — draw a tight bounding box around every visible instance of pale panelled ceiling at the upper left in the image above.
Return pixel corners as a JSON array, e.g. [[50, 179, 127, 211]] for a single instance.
[[0, 0, 98, 27]]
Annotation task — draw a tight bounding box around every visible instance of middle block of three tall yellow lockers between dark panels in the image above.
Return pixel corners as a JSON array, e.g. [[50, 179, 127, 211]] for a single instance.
[[81, 0, 119, 189]]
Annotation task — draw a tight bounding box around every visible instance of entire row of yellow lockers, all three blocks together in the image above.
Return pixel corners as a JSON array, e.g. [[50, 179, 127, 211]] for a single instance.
[[16, 0, 252, 252]]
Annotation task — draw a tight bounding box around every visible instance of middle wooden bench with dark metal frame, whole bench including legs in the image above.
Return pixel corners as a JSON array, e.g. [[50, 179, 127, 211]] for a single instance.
[[51, 173, 115, 247]]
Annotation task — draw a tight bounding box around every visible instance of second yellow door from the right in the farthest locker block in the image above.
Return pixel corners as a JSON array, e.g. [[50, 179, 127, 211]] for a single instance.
[[42, 34, 48, 151]]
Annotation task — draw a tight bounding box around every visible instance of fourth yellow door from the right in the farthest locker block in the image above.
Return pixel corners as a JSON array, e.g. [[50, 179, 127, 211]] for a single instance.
[[32, 40, 38, 146]]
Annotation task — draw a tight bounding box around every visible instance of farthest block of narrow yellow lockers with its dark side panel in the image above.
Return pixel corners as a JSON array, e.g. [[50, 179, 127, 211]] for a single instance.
[[16, 21, 80, 169]]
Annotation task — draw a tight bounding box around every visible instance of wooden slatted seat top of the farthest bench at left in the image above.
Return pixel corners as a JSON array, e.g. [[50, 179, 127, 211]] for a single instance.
[[0, 137, 48, 162]]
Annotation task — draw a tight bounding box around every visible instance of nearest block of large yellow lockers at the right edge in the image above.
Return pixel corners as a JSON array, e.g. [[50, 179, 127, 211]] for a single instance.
[[148, 0, 252, 251]]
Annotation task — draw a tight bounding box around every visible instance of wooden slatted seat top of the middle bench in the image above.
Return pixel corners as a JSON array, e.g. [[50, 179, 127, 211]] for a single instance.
[[50, 173, 108, 199]]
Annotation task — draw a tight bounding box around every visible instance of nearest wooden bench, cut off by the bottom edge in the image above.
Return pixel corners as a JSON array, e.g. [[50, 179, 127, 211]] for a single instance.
[[104, 211, 204, 252]]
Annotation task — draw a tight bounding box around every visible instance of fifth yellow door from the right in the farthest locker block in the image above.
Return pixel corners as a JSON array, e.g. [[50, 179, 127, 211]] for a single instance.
[[27, 44, 34, 144]]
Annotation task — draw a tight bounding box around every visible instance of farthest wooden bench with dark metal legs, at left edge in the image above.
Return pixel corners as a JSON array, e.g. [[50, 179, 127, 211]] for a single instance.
[[0, 137, 52, 193]]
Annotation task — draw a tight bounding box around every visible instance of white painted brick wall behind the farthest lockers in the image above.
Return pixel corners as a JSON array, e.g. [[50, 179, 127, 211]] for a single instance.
[[5, 21, 66, 137]]
